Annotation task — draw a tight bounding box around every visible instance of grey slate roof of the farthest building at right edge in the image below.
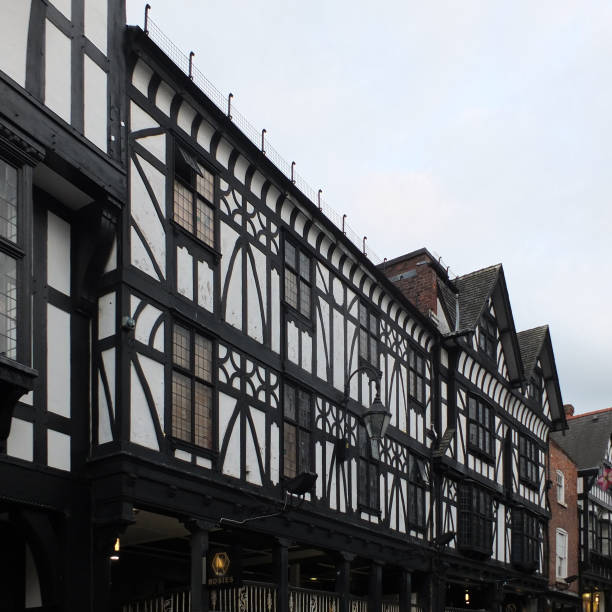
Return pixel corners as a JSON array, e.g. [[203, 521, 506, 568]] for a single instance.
[[550, 408, 612, 470]]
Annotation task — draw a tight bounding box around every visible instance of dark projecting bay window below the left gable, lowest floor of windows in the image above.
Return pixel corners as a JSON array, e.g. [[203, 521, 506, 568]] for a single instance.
[[457, 483, 493, 556]]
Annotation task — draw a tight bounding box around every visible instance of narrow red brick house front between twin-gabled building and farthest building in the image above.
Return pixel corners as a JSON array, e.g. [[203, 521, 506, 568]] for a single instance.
[[548, 440, 578, 593]]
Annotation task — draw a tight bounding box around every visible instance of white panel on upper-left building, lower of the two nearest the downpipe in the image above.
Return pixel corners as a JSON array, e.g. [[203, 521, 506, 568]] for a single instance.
[[83, 54, 108, 153]]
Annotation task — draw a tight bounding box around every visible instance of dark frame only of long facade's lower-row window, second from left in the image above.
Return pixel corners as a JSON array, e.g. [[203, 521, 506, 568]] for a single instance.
[[282, 381, 314, 479]]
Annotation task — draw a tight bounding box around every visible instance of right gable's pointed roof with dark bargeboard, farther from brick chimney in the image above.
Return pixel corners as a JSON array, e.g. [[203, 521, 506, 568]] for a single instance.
[[516, 325, 567, 430]]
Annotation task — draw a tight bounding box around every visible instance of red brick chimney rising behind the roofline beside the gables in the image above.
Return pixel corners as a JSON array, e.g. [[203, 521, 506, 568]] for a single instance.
[[380, 249, 448, 317]]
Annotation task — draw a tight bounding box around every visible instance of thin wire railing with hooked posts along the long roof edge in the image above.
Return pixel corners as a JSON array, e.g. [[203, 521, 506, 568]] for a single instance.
[[144, 5, 382, 264]]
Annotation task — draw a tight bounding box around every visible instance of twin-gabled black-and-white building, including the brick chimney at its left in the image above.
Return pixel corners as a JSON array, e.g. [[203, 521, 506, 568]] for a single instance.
[[385, 249, 565, 610]]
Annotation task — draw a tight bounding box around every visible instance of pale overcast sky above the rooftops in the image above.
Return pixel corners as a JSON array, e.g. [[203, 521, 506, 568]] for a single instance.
[[127, 0, 612, 412]]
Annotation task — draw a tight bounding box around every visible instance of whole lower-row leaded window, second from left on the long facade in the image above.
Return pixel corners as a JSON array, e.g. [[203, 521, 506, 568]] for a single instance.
[[283, 383, 312, 478]]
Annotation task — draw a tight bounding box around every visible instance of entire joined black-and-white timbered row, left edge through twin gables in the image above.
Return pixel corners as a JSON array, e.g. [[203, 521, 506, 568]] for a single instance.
[[0, 0, 564, 612]]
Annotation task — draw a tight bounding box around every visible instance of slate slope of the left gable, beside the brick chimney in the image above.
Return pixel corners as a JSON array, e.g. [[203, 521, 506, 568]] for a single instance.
[[440, 264, 501, 332]]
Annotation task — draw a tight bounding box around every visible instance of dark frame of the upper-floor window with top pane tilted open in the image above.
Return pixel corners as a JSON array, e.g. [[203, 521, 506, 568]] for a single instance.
[[170, 138, 220, 252]]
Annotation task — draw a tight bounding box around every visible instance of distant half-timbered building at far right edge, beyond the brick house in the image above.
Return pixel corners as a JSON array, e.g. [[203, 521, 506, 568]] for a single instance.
[[553, 408, 612, 612]]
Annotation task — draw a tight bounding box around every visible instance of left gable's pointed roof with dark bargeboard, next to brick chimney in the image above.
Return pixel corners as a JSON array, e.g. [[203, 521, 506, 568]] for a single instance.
[[439, 264, 523, 382]]
